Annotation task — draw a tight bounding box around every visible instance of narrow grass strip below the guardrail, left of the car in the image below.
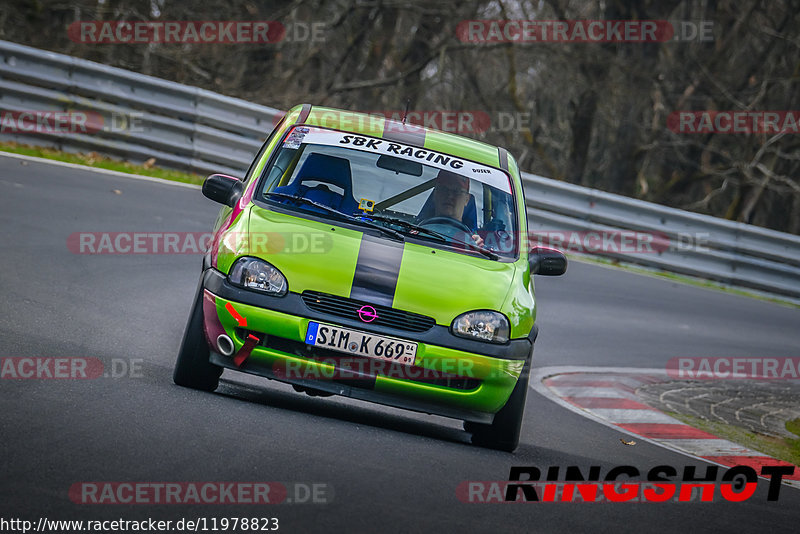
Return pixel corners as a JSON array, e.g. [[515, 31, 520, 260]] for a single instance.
[[0, 141, 204, 185]]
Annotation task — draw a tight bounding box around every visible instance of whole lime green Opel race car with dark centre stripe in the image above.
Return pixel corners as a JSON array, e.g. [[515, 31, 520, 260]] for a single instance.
[[174, 104, 567, 451]]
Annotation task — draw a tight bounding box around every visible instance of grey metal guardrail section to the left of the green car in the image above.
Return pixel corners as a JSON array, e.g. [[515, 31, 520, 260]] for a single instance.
[[0, 41, 282, 178]]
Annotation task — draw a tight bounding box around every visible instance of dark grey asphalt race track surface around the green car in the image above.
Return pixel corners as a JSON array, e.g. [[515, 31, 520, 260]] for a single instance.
[[0, 156, 800, 533]]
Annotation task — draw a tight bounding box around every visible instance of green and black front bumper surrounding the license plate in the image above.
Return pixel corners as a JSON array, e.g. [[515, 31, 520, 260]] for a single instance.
[[203, 269, 532, 423]]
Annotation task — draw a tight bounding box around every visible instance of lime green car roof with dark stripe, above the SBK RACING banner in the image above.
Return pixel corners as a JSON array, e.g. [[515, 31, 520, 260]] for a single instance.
[[286, 104, 510, 171]]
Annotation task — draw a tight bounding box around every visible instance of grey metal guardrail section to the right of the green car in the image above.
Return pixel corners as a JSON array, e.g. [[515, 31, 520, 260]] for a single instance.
[[523, 174, 800, 299]]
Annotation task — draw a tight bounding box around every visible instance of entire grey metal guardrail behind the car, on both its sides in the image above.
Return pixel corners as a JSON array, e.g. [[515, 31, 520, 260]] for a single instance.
[[0, 41, 800, 299]]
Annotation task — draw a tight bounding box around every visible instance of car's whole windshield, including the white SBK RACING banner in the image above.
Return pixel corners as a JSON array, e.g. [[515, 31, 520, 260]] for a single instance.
[[259, 126, 517, 259]]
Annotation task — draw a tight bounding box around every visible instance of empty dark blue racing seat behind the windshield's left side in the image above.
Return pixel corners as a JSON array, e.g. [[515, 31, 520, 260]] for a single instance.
[[275, 153, 358, 214]]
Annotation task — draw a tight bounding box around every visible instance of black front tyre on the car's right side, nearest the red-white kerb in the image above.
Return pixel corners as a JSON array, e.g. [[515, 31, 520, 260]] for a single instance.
[[464, 357, 532, 452]]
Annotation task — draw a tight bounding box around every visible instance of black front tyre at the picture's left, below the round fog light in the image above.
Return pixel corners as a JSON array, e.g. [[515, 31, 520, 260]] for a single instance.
[[172, 282, 222, 391]]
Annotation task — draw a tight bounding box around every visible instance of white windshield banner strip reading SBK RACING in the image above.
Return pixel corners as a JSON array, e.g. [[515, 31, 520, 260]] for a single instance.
[[284, 128, 511, 193]]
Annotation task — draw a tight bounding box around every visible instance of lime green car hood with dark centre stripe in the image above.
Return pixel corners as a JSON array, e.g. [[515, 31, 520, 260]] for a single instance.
[[249, 206, 515, 324]]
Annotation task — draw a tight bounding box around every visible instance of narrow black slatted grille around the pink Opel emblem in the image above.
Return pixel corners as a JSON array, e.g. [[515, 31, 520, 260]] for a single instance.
[[302, 291, 436, 332]]
